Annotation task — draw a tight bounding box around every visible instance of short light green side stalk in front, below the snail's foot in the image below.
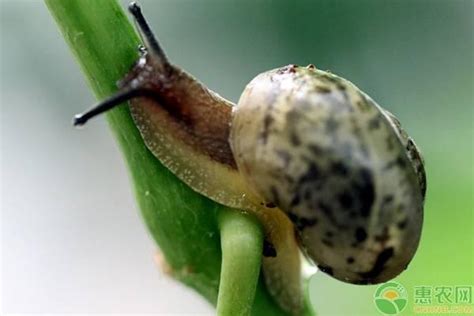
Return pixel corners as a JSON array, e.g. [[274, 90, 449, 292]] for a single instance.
[[217, 210, 263, 316]]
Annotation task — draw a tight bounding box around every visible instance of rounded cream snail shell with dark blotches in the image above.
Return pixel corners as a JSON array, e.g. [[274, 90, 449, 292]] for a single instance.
[[230, 65, 426, 284]]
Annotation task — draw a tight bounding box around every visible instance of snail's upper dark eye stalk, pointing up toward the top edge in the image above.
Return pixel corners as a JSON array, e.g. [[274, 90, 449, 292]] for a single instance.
[[128, 2, 169, 65]]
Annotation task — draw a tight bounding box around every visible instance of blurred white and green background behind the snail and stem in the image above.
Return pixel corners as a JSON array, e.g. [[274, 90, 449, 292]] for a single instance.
[[0, 0, 474, 315]]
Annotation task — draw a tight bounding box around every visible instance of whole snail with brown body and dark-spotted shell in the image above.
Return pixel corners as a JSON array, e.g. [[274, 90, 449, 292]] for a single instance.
[[74, 3, 426, 305]]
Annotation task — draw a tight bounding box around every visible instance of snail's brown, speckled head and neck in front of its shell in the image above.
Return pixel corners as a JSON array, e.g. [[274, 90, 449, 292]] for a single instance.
[[119, 54, 260, 210]]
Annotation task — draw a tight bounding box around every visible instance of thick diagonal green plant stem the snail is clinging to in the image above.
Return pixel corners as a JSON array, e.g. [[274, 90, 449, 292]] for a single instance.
[[45, 0, 312, 315]]
